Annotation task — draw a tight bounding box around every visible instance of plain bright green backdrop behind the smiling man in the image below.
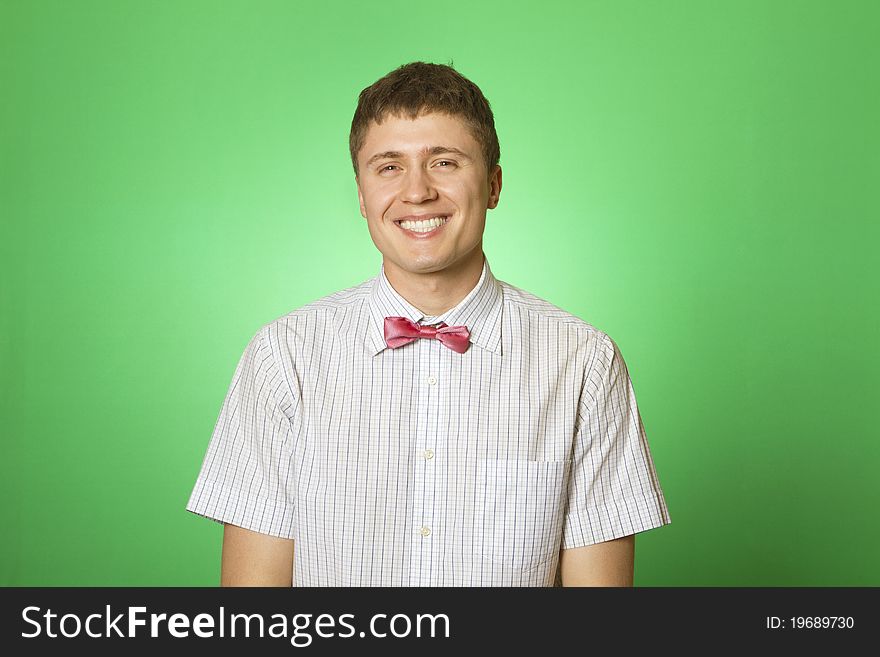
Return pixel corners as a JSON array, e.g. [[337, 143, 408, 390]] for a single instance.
[[0, 0, 880, 586]]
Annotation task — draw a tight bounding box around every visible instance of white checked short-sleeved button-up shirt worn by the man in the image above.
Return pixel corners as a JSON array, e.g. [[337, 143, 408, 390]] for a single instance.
[[187, 259, 670, 586]]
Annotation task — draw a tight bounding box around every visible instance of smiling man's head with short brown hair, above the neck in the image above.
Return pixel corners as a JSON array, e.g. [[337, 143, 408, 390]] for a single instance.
[[349, 62, 501, 281]]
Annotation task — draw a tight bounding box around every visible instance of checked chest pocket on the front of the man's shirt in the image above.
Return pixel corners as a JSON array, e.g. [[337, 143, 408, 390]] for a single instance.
[[474, 460, 571, 571]]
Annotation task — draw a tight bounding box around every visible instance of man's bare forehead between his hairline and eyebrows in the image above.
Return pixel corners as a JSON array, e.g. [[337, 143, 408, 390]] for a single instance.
[[359, 112, 479, 159]]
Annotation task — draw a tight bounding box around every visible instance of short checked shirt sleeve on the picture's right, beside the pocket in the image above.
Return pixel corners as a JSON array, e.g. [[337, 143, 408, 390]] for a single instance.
[[562, 334, 671, 549]]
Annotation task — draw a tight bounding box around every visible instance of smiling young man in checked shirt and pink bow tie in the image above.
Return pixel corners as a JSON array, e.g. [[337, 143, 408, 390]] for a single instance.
[[187, 62, 670, 586]]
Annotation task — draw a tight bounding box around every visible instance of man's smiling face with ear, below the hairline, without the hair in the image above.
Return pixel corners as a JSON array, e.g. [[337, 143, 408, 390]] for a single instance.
[[356, 113, 501, 280]]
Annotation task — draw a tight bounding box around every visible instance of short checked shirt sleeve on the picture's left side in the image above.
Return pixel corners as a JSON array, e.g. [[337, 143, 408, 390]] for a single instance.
[[186, 325, 295, 538]]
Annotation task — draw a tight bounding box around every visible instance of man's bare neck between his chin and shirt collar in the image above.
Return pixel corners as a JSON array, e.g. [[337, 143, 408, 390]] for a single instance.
[[383, 246, 485, 316]]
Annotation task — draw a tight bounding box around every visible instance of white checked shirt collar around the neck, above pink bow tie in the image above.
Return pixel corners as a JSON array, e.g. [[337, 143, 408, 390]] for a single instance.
[[367, 255, 503, 356]]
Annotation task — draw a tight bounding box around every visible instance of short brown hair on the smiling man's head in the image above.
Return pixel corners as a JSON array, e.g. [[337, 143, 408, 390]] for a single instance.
[[348, 62, 501, 176]]
